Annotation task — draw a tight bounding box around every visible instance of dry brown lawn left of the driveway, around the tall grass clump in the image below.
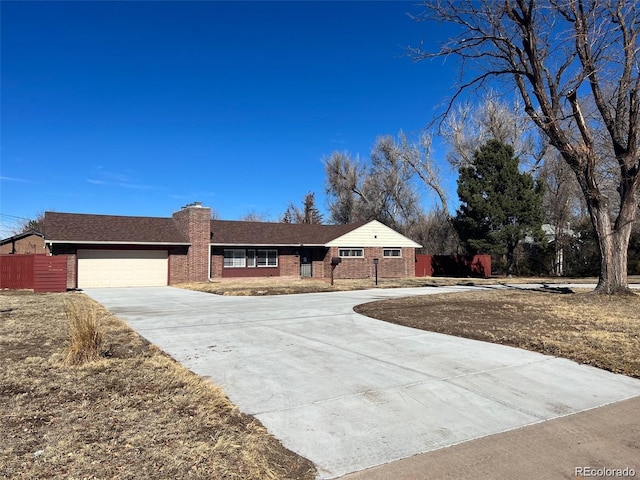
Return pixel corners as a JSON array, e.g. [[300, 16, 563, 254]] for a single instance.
[[0, 292, 315, 480]]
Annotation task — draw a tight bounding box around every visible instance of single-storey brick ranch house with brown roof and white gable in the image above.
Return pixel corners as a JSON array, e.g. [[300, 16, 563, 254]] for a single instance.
[[45, 203, 420, 288]]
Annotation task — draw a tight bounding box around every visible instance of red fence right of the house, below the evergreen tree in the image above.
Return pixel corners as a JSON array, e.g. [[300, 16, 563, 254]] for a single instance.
[[416, 255, 491, 277]]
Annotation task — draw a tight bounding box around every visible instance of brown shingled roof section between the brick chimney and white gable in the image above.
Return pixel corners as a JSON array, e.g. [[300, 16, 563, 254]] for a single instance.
[[211, 220, 364, 246]]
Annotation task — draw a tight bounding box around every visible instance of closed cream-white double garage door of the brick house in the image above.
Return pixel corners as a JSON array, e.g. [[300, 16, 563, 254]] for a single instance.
[[78, 250, 169, 288]]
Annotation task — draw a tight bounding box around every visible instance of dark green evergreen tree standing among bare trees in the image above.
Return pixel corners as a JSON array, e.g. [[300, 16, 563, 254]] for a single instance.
[[454, 140, 543, 273]]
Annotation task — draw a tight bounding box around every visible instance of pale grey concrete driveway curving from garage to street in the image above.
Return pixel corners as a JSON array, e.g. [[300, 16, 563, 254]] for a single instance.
[[86, 287, 640, 478]]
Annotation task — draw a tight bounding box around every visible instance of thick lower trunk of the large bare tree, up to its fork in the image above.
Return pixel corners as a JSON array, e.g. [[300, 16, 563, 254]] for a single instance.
[[589, 201, 635, 295]]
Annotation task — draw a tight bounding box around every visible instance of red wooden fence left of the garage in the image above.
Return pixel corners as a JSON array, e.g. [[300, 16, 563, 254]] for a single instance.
[[0, 254, 67, 292]]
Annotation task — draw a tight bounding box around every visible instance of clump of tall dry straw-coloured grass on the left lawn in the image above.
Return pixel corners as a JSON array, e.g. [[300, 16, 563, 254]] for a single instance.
[[65, 300, 104, 365]]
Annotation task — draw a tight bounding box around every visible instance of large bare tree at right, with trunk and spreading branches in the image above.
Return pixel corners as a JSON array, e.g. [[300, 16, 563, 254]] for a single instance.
[[413, 0, 640, 294]]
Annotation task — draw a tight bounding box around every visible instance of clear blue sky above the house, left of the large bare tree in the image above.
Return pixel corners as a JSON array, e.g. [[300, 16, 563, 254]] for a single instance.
[[0, 1, 455, 236]]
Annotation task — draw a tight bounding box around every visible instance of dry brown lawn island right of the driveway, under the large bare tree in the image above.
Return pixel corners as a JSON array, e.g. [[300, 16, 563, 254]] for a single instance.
[[355, 290, 640, 378]]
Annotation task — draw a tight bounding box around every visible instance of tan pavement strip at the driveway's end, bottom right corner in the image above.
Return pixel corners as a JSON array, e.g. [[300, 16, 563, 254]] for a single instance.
[[340, 396, 640, 480]]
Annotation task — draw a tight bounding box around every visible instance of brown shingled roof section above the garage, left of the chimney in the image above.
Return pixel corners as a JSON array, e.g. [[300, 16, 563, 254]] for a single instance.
[[44, 212, 190, 245]]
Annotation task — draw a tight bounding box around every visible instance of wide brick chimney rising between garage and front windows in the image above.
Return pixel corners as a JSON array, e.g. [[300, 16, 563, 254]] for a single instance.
[[173, 202, 211, 282]]
